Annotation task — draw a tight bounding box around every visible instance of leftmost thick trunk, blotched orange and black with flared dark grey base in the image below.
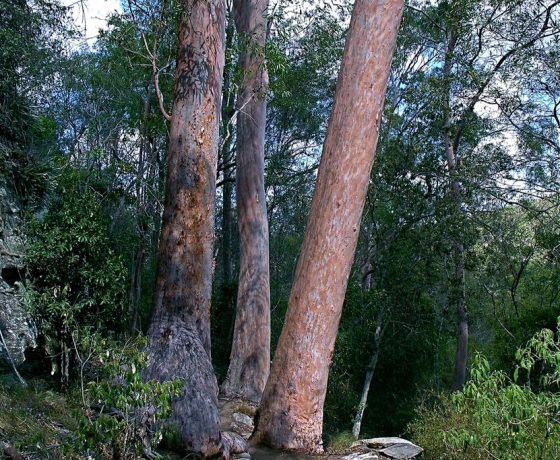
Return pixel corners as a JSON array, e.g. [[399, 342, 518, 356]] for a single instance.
[[145, 0, 225, 456]]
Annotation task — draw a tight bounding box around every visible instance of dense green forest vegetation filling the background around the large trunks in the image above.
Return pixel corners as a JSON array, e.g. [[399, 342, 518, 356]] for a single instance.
[[0, 0, 560, 459]]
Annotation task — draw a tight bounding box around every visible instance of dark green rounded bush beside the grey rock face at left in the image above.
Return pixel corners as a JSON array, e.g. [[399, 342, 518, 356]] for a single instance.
[[24, 170, 127, 381]]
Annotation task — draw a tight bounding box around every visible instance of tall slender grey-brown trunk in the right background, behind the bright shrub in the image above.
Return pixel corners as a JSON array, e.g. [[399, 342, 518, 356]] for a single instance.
[[443, 30, 469, 391]]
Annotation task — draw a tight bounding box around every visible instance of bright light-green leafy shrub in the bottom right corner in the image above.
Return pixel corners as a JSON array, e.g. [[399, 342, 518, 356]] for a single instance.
[[409, 318, 560, 460]]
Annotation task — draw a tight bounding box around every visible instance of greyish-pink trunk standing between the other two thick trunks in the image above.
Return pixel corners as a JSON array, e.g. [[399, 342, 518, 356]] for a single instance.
[[221, 0, 270, 402]]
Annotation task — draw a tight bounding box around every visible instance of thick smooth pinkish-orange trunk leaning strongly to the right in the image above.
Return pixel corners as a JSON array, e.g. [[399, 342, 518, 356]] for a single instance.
[[254, 0, 403, 453]]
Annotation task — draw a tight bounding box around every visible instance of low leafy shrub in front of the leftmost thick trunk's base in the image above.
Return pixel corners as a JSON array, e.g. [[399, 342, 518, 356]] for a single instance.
[[72, 335, 183, 459]]
